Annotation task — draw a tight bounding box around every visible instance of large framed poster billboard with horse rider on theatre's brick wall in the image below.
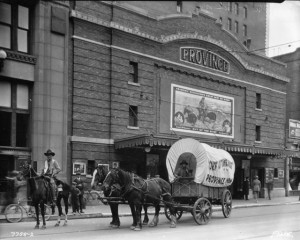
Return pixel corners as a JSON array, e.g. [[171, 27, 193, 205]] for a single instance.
[[171, 84, 234, 138]]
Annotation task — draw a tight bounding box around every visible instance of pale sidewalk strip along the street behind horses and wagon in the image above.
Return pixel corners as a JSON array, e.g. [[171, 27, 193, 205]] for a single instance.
[[0, 196, 300, 223]]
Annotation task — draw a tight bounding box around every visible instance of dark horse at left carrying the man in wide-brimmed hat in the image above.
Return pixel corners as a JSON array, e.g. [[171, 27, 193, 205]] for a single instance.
[[19, 164, 70, 229]]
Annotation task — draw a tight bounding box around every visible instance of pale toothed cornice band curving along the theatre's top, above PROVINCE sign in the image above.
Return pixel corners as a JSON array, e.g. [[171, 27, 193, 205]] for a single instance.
[[70, 10, 290, 82]]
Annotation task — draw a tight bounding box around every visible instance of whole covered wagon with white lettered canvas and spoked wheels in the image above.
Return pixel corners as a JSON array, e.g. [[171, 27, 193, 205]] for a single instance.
[[165, 138, 235, 224]]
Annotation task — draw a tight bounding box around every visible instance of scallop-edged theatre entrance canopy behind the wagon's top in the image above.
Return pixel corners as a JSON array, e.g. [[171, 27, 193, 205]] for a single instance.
[[114, 134, 300, 157]]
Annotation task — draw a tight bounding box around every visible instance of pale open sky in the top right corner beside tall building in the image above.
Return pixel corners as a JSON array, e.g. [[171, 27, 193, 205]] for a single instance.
[[267, 0, 300, 57]]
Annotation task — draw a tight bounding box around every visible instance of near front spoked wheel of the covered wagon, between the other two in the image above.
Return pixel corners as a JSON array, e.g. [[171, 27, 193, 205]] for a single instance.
[[193, 198, 212, 225]]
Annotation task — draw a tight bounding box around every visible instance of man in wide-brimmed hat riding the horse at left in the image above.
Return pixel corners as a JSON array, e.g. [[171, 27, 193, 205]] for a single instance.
[[43, 149, 61, 207]]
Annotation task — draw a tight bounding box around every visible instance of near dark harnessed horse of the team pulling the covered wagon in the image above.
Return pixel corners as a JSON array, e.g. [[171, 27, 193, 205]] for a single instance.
[[103, 168, 176, 231]]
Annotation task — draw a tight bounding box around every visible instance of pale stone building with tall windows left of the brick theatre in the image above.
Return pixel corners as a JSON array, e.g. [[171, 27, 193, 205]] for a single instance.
[[0, 1, 70, 203]]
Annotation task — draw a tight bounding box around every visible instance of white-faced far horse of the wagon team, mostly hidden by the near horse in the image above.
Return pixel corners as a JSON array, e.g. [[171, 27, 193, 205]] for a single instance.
[[91, 166, 149, 228]]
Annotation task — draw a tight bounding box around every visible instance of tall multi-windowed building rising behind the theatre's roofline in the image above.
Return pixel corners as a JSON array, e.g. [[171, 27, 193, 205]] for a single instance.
[[117, 1, 268, 55]]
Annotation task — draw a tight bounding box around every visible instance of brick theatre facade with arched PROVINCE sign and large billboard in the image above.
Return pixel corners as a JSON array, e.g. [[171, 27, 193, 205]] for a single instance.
[[68, 1, 296, 198]]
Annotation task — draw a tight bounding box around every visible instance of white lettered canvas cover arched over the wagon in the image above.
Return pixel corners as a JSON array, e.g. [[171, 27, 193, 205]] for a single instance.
[[166, 138, 235, 187]]
